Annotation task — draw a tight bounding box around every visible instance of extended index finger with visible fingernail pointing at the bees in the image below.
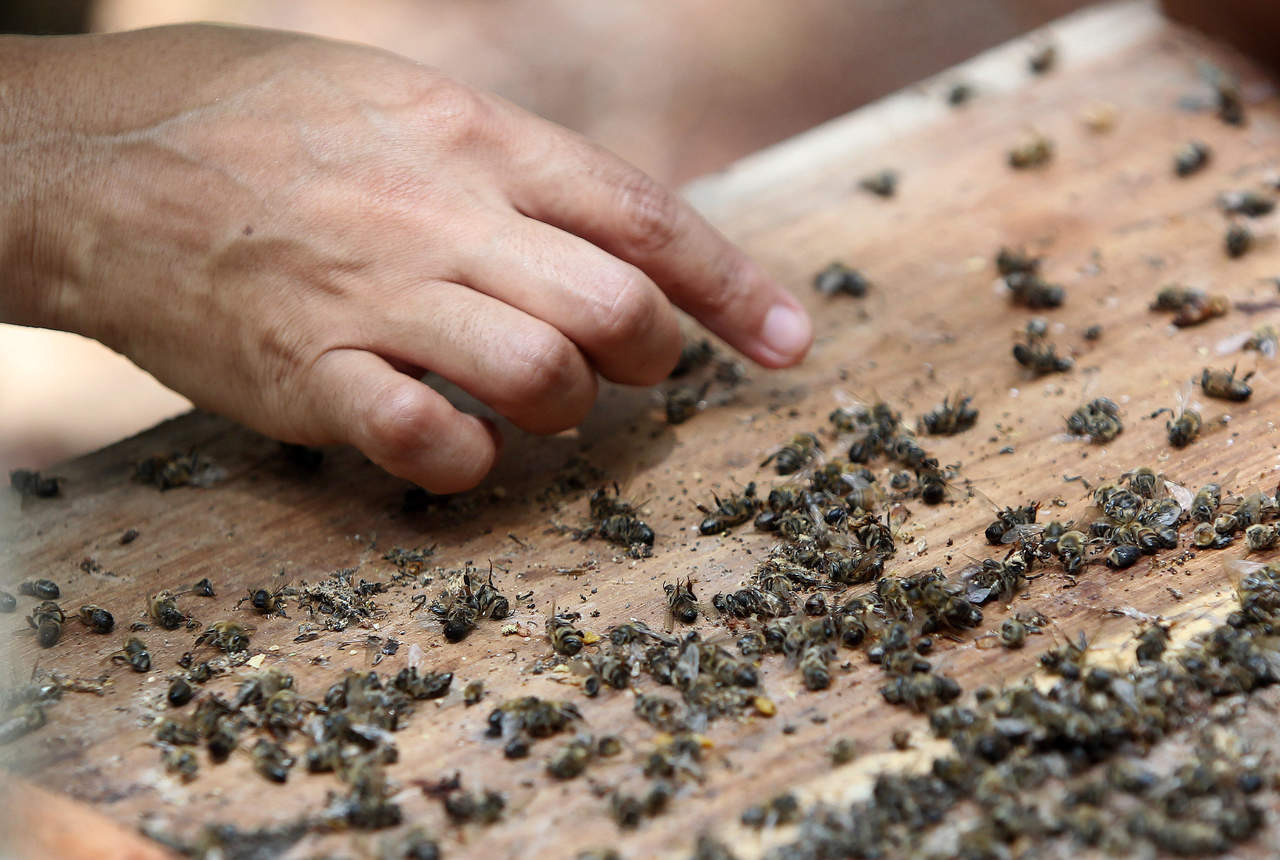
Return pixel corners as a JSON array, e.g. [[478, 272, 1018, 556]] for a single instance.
[[496, 118, 813, 367]]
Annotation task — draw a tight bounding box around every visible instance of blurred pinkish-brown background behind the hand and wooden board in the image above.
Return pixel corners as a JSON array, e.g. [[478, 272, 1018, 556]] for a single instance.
[[0, 0, 1087, 470]]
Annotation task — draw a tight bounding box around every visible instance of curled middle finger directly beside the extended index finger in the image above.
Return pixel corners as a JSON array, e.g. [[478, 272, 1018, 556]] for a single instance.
[[461, 215, 681, 385]]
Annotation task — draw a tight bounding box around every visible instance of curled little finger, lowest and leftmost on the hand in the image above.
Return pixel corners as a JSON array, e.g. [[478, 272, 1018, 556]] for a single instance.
[[310, 349, 500, 493]]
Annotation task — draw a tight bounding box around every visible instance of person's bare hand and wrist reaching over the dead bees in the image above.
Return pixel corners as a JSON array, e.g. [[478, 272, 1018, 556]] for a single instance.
[[0, 26, 812, 493]]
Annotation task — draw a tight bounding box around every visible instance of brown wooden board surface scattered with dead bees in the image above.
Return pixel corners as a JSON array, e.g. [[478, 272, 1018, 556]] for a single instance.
[[0, 3, 1280, 857]]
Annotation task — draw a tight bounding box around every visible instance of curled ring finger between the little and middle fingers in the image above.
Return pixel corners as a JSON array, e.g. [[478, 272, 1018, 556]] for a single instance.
[[364, 282, 598, 434]]
